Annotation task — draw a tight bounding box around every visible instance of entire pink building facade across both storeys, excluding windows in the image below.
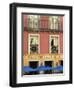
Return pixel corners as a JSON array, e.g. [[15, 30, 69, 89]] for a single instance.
[[23, 15, 63, 54]]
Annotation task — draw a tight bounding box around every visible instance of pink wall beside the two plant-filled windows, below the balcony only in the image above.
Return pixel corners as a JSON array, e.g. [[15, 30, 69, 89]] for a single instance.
[[23, 31, 63, 54]]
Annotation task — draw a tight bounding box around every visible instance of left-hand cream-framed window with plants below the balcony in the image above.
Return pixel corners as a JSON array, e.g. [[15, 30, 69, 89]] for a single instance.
[[28, 34, 39, 54]]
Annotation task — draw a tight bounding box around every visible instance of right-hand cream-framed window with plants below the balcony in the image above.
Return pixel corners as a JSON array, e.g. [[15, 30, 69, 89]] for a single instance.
[[50, 35, 60, 53]]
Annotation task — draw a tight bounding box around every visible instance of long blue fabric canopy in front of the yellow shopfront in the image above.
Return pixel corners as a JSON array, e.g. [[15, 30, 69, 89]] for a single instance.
[[23, 66, 63, 72]]
